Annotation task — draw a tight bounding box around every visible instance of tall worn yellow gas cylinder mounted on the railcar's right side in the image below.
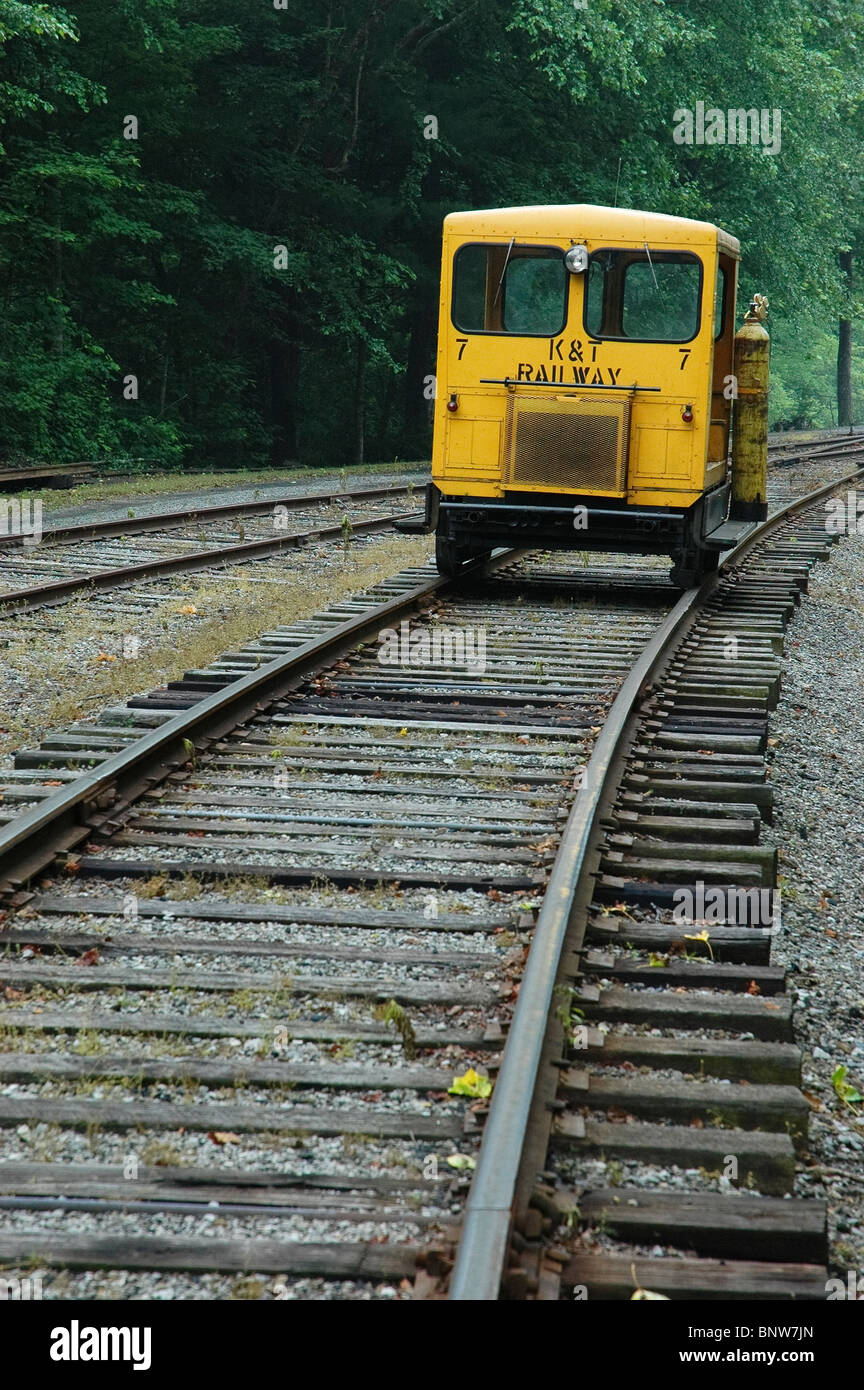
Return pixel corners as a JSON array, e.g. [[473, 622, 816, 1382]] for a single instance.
[[729, 295, 771, 521]]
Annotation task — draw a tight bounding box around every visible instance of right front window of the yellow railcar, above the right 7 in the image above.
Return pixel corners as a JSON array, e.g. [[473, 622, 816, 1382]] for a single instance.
[[585, 249, 701, 343]]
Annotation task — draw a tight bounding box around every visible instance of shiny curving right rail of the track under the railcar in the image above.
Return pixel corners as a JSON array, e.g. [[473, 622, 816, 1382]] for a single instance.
[[449, 455, 864, 1302]]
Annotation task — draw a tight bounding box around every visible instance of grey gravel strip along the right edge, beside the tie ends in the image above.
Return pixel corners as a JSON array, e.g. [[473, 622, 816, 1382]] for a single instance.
[[764, 522, 864, 1272]]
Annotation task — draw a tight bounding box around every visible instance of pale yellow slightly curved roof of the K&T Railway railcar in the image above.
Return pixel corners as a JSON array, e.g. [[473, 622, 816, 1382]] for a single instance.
[[445, 203, 740, 256]]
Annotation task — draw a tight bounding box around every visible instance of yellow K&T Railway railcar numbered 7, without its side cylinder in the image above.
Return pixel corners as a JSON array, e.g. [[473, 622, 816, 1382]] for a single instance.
[[416, 204, 739, 582]]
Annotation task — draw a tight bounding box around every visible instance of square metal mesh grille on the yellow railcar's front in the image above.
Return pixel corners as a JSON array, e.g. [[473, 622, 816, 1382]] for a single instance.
[[504, 396, 631, 492]]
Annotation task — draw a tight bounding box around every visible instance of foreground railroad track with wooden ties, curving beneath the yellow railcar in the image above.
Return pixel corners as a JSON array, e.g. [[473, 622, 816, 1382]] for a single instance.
[[0, 453, 861, 1298]]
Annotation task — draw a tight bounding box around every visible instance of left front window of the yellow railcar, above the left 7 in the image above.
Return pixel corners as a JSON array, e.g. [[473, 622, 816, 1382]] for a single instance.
[[451, 243, 568, 338]]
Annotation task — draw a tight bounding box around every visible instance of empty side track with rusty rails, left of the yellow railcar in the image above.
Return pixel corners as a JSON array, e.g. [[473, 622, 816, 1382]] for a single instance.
[[0, 484, 413, 614]]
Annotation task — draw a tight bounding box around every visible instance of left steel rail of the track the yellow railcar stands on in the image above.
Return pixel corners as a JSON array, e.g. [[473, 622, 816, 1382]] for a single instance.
[[0, 549, 524, 892]]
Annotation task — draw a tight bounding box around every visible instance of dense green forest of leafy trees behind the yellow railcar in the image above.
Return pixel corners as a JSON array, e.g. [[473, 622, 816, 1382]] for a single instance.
[[0, 0, 864, 466]]
